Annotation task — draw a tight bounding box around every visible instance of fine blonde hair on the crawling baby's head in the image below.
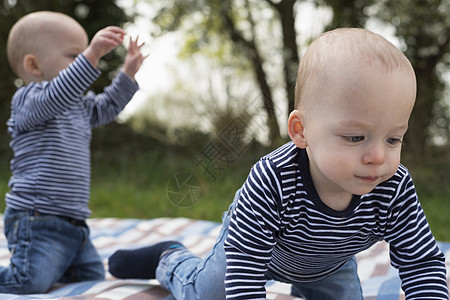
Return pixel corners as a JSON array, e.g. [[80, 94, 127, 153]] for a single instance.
[[294, 28, 414, 112]]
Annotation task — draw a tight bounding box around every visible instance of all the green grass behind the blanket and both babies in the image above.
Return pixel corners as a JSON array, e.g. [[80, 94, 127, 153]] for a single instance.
[[0, 124, 450, 242]]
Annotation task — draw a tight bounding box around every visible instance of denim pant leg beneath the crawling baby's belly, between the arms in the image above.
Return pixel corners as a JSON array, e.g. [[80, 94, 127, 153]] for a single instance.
[[291, 257, 363, 300]]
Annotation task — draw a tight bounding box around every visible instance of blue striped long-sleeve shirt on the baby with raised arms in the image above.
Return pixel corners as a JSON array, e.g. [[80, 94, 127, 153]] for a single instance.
[[6, 54, 138, 220]]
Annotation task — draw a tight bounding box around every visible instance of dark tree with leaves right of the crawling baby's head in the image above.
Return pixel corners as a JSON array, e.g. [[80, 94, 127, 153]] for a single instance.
[[377, 0, 450, 161]]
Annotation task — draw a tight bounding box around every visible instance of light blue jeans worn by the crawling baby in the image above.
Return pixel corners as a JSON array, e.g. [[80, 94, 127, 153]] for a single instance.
[[156, 191, 363, 300]]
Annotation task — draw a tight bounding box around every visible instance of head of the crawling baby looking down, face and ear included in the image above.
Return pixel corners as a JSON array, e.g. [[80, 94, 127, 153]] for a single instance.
[[288, 28, 416, 197]]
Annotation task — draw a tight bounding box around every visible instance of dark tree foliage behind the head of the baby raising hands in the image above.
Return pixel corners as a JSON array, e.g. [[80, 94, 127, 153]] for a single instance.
[[0, 0, 134, 153]]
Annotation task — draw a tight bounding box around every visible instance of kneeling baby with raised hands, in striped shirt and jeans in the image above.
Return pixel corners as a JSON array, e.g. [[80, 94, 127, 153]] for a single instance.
[[0, 11, 145, 294]]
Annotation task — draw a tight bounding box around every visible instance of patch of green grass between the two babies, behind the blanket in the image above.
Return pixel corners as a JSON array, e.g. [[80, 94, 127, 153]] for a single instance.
[[90, 149, 250, 221]]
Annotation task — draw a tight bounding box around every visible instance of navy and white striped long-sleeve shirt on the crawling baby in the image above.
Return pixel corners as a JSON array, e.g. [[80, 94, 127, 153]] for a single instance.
[[225, 142, 448, 299]]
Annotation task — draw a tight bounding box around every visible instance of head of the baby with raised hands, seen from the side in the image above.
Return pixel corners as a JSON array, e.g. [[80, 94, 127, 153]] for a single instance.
[[7, 11, 88, 83]]
